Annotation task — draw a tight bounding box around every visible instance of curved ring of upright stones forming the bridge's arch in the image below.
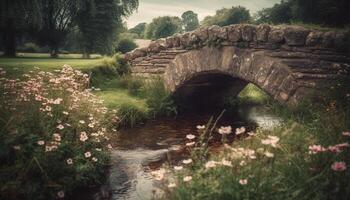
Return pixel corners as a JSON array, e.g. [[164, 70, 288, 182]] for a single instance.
[[164, 46, 296, 102]]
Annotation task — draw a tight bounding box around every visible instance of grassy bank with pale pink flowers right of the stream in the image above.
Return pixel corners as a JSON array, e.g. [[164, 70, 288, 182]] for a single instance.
[[163, 80, 350, 200]]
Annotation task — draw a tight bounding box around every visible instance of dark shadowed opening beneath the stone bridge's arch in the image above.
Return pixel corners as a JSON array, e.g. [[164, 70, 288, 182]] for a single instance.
[[174, 72, 248, 113]]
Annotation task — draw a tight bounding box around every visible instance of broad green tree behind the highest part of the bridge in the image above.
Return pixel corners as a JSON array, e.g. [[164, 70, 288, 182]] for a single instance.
[[202, 6, 250, 26]]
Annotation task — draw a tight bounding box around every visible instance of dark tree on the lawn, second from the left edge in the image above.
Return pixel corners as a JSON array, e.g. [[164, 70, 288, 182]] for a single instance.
[[35, 0, 77, 57]]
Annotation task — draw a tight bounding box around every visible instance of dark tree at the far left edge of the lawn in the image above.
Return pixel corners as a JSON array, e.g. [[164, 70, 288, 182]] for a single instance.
[[0, 0, 41, 57]]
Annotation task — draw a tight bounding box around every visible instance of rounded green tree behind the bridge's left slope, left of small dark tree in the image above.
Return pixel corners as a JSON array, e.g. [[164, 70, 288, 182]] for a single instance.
[[145, 16, 181, 39]]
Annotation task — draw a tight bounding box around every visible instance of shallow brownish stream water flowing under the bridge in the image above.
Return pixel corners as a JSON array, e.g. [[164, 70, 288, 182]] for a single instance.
[[85, 107, 280, 200]]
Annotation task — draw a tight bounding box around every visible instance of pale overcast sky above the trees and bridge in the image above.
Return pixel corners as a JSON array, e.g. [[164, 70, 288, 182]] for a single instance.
[[126, 0, 280, 28]]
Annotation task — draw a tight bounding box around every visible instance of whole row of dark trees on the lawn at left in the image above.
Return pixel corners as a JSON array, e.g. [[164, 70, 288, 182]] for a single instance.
[[0, 0, 138, 57]]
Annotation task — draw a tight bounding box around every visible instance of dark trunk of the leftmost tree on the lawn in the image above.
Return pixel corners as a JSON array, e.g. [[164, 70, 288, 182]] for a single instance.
[[4, 20, 16, 57]]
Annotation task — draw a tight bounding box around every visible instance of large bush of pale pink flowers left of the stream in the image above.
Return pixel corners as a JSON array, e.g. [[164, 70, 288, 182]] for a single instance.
[[0, 66, 117, 200]]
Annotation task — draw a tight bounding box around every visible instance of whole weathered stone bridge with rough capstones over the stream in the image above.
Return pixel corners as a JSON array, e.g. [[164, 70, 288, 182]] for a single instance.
[[125, 24, 350, 105]]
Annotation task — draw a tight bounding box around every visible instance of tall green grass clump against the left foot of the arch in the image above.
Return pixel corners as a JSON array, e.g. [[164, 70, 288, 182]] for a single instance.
[[144, 78, 177, 117]]
